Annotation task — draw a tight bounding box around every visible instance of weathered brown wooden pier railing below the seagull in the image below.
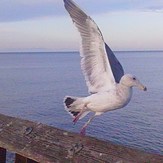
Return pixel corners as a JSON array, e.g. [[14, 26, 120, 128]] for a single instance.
[[0, 114, 163, 163]]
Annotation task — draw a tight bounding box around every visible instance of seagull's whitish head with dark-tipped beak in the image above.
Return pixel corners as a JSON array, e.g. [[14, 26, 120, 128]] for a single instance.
[[120, 74, 147, 91]]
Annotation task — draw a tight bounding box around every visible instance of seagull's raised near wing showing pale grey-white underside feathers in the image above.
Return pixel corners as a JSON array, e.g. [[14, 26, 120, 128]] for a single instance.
[[64, 0, 123, 93]]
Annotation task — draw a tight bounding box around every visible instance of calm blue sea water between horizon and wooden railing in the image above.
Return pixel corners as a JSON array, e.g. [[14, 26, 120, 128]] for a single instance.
[[0, 52, 163, 154]]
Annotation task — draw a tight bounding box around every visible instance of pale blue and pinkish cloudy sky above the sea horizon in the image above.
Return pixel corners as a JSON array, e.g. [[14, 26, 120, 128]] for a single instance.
[[0, 0, 163, 52]]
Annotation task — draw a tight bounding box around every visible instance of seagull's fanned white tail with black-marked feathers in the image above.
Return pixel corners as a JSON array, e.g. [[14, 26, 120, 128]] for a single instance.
[[63, 96, 89, 119]]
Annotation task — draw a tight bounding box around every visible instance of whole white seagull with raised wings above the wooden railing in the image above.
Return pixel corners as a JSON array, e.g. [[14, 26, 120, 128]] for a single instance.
[[63, 0, 147, 135]]
